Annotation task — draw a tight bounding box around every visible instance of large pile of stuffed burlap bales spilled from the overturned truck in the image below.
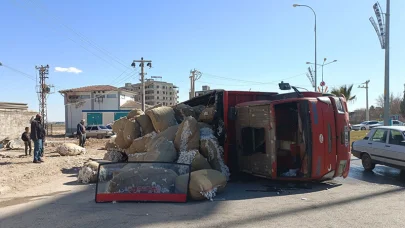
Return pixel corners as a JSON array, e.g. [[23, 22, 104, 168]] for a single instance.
[[85, 104, 229, 200]]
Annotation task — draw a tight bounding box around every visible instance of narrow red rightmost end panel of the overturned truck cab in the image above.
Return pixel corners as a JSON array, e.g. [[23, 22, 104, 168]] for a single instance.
[[330, 97, 350, 177]]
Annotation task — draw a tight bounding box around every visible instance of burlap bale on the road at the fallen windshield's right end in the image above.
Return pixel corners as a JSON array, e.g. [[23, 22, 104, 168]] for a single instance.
[[175, 169, 226, 200]]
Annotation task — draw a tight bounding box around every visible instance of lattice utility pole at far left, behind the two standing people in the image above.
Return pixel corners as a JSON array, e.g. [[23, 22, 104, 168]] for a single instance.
[[35, 65, 53, 134]]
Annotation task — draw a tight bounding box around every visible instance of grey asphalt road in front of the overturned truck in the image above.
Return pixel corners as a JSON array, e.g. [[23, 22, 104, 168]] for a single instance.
[[0, 158, 405, 228]]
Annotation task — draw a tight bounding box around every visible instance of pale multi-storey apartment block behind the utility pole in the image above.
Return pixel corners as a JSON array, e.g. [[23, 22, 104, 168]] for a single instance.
[[124, 79, 179, 106]]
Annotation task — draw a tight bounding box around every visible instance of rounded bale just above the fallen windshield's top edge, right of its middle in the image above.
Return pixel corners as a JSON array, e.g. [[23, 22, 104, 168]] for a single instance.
[[144, 138, 177, 162]]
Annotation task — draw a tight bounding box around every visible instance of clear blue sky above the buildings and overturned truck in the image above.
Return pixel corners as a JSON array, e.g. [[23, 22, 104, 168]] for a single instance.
[[0, 0, 405, 121]]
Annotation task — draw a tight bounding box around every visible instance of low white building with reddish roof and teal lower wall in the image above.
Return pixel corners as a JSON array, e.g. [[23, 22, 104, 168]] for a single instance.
[[59, 85, 135, 134]]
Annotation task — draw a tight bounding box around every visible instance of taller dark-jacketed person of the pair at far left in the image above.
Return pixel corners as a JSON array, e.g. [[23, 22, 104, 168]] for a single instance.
[[31, 114, 45, 163]]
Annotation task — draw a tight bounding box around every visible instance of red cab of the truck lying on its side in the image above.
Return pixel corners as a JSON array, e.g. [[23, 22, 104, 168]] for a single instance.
[[235, 92, 350, 180]]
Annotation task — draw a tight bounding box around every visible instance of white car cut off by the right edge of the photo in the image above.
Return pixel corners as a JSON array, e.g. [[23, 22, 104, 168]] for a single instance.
[[352, 126, 405, 171]]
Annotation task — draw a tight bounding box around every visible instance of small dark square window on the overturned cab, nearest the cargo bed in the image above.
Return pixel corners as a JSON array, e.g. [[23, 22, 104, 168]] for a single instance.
[[241, 127, 266, 155]]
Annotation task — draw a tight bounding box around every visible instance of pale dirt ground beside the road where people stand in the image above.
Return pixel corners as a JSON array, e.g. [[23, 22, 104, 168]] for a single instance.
[[0, 136, 108, 198]]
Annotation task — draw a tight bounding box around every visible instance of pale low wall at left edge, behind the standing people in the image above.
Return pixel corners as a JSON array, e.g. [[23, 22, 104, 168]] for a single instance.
[[0, 109, 37, 140]]
